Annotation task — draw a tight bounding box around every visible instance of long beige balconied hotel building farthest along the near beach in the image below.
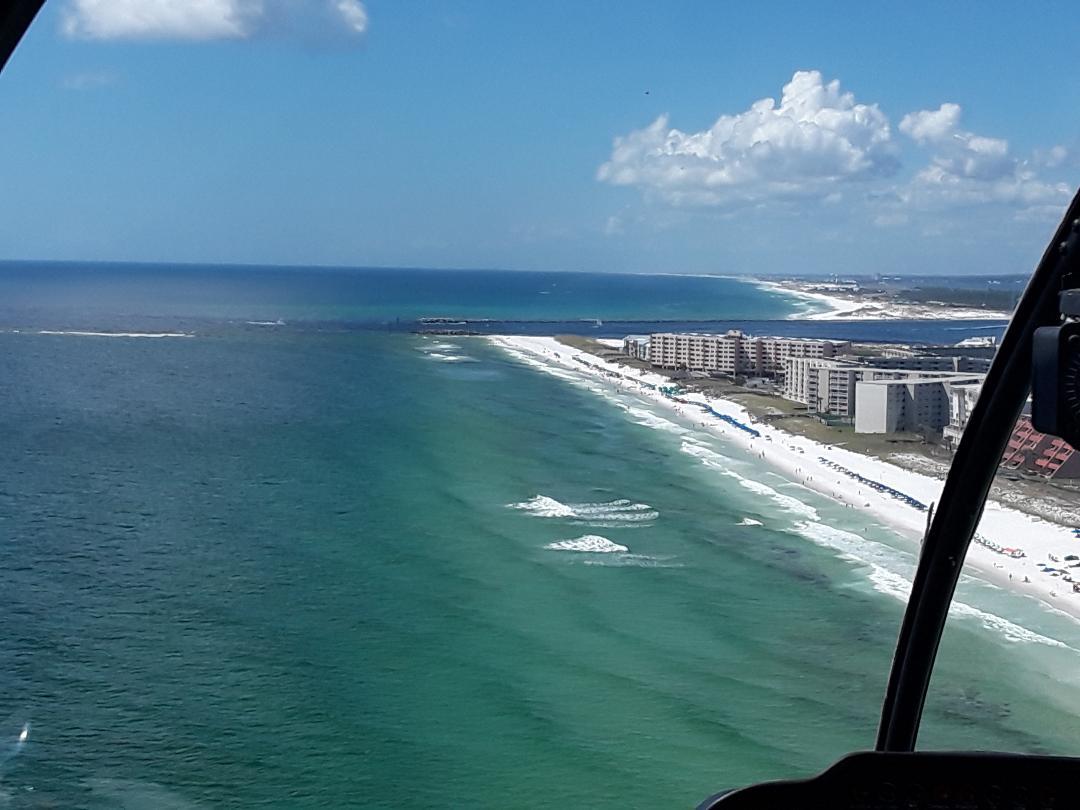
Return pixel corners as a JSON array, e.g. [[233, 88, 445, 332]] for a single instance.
[[649, 329, 851, 377]]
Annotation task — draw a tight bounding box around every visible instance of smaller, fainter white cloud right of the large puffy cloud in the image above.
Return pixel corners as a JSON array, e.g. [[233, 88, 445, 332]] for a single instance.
[[900, 104, 1070, 206]]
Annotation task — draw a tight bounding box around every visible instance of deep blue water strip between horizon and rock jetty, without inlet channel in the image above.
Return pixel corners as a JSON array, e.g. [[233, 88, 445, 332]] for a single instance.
[[0, 262, 796, 327]]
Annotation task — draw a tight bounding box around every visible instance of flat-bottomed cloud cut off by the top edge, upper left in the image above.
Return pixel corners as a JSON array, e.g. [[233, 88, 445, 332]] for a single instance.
[[60, 0, 367, 41]]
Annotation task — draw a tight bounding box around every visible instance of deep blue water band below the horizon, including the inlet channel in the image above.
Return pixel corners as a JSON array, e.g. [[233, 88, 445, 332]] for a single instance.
[[0, 261, 1003, 343]]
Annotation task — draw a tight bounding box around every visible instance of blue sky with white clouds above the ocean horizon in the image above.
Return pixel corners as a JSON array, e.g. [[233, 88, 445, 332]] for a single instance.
[[0, 0, 1080, 273]]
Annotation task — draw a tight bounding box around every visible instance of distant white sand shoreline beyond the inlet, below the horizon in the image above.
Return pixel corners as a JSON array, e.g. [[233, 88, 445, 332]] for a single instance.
[[744, 276, 1012, 321]]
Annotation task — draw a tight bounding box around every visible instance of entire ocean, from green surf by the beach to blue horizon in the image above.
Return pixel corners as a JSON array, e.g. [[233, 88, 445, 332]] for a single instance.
[[0, 265, 1067, 809]]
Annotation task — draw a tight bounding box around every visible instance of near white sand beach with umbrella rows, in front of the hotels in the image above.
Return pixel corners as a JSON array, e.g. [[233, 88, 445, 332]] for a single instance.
[[486, 336, 1080, 621]]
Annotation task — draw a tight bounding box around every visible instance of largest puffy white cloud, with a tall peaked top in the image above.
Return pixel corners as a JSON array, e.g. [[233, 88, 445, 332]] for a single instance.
[[597, 70, 899, 205]]
